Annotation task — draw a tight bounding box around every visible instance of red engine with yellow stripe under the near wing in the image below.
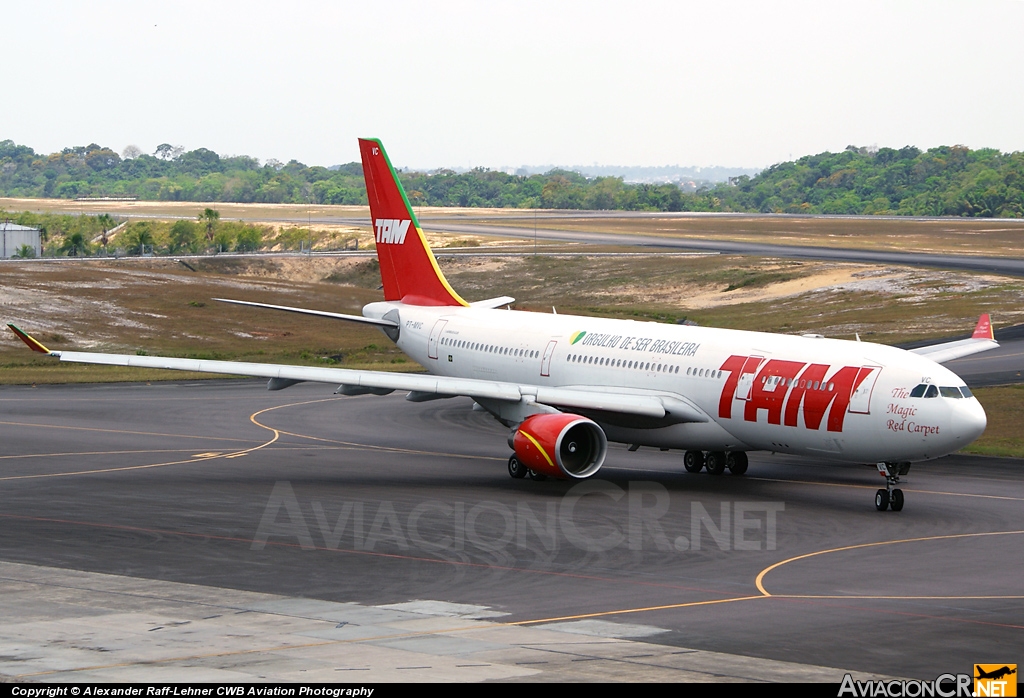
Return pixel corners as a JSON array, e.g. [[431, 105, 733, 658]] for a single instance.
[[509, 413, 608, 480]]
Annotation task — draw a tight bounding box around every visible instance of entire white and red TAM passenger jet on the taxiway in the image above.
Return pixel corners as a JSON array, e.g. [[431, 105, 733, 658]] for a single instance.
[[11, 139, 998, 511]]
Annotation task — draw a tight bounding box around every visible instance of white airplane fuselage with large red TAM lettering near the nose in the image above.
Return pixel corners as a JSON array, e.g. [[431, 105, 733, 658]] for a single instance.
[[364, 302, 986, 463]]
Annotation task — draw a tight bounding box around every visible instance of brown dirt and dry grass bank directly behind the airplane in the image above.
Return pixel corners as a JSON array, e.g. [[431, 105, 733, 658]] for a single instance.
[[0, 253, 1024, 354]]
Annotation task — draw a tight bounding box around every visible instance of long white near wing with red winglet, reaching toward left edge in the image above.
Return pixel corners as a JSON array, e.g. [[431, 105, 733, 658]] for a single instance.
[[7, 323, 708, 422]]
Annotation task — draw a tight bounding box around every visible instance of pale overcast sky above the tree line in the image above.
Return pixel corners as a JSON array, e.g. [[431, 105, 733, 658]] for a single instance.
[[0, 0, 1024, 168]]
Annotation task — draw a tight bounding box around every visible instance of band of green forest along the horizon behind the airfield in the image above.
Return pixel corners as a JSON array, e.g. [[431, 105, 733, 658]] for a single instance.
[[0, 140, 1024, 218]]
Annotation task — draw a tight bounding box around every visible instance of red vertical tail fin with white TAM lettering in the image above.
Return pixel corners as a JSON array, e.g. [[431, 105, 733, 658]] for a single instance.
[[359, 138, 468, 305]]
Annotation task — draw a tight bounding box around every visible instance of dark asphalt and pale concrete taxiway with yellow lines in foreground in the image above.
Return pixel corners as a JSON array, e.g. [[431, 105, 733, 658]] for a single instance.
[[0, 381, 1024, 683]]
